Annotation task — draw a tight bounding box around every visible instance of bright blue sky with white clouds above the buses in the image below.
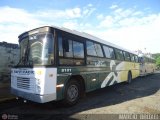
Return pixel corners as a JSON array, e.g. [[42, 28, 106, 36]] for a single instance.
[[0, 0, 160, 53]]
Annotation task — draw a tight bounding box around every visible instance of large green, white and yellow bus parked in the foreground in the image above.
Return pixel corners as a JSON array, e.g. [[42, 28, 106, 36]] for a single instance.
[[11, 26, 140, 106]]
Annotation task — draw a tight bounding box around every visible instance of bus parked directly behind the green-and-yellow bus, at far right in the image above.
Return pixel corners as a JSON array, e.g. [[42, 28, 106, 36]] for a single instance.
[[138, 54, 156, 76]]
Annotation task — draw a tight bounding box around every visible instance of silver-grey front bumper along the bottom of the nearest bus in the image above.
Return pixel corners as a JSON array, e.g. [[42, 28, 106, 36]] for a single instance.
[[11, 88, 56, 103]]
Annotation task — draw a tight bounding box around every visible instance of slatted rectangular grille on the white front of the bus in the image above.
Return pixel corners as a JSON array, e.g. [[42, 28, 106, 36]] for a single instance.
[[17, 77, 30, 90]]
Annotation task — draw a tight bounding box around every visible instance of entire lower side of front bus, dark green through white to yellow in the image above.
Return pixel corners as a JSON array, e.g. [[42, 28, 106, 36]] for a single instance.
[[57, 57, 139, 100]]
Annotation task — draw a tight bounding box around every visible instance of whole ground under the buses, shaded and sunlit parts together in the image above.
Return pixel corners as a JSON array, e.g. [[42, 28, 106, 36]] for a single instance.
[[0, 72, 160, 120]]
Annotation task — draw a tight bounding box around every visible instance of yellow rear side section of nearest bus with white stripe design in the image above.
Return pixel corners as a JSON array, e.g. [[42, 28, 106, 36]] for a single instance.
[[101, 60, 139, 88]]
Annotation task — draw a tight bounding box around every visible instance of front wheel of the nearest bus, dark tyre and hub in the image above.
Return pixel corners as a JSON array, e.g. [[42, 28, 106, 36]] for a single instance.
[[64, 80, 80, 106]]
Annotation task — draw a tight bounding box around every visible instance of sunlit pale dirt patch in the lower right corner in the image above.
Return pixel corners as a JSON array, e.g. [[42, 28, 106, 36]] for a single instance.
[[76, 90, 160, 114]]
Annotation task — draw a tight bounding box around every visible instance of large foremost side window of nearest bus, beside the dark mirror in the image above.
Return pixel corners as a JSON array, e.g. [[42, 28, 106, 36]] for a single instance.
[[58, 37, 84, 65]]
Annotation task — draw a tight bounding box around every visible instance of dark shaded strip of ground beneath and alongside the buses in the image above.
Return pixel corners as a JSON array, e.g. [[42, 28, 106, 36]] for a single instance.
[[0, 72, 160, 120]]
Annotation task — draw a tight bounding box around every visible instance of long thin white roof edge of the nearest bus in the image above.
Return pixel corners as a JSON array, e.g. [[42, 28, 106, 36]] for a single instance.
[[19, 26, 137, 55]]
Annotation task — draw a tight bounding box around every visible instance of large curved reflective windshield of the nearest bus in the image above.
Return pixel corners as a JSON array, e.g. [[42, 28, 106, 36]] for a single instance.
[[18, 33, 54, 66]]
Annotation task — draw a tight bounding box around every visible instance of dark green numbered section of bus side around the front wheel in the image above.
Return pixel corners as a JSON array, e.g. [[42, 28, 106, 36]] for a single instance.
[[57, 66, 108, 100]]
